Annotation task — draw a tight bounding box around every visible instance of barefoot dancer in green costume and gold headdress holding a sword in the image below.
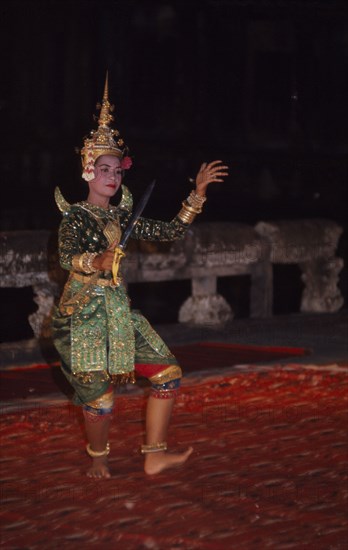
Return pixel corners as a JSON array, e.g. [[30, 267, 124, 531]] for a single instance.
[[52, 74, 228, 478]]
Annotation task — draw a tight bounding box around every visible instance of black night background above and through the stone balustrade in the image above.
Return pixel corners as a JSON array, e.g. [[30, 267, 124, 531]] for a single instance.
[[0, 0, 348, 338]]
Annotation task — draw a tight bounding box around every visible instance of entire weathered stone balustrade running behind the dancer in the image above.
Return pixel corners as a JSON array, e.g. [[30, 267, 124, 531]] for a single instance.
[[0, 220, 343, 344]]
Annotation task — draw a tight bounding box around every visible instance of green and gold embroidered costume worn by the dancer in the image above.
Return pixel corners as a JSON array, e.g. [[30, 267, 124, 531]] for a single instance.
[[52, 186, 188, 404]]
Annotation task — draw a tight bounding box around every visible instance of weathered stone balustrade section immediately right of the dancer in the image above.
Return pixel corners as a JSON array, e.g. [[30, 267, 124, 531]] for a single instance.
[[123, 223, 271, 325]]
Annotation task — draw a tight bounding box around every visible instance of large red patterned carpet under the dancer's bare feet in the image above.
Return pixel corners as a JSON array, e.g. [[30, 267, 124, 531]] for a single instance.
[[1, 366, 348, 550]]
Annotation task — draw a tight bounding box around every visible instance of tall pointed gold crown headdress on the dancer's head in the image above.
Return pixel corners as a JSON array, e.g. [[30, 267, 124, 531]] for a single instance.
[[81, 73, 132, 181]]
